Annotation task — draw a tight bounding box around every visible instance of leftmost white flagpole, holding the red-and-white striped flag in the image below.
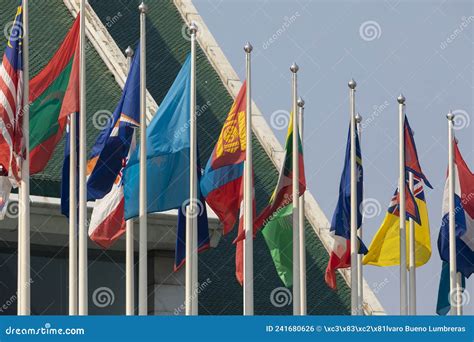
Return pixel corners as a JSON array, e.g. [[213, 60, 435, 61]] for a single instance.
[[18, 0, 31, 316]]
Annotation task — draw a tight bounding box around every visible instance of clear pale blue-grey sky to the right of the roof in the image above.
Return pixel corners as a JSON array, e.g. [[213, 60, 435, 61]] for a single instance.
[[194, 0, 474, 314]]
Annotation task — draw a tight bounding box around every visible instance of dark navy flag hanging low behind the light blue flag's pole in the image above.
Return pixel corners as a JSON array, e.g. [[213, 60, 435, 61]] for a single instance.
[[174, 168, 210, 271]]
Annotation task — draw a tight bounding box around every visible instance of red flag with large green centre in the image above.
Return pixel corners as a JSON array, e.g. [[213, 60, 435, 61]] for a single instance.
[[30, 16, 80, 174]]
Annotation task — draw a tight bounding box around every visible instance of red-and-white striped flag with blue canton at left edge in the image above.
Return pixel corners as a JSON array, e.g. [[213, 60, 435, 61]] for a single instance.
[[0, 4, 24, 219]]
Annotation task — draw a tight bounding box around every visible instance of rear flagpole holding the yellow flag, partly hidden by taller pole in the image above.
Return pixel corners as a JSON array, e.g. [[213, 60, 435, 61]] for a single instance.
[[408, 171, 416, 315]]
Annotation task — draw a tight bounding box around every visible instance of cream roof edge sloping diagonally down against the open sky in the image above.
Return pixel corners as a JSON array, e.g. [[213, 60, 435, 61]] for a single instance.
[[174, 0, 385, 315]]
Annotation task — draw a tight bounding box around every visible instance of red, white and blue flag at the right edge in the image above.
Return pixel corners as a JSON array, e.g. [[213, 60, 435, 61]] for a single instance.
[[438, 142, 474, 278]]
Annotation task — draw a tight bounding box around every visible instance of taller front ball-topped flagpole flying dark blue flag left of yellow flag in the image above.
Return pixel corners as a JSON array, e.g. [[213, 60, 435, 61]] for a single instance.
[[348, 79, 359, 315]]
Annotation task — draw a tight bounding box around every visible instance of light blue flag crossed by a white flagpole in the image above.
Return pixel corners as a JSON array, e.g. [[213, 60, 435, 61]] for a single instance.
[[123, 56, 191, 219]]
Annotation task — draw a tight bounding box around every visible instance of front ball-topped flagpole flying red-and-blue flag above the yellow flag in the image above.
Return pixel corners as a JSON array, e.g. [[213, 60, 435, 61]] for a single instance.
[[397, 94, 408, 315]]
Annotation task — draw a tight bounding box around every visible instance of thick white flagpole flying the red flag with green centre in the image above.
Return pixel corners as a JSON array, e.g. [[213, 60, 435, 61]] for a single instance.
[[78, 0, 89, 315]]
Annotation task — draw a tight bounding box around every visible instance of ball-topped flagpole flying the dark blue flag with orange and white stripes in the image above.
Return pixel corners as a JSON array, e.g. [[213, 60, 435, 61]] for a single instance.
[[138, 2, 148, 316]]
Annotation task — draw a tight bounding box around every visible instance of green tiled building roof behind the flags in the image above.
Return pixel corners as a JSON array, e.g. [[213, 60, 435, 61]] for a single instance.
[[0, 0, 379, 315]]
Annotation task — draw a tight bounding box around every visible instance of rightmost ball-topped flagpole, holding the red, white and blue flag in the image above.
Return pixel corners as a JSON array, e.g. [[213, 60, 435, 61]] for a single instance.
[[446, 111, 461, 315]]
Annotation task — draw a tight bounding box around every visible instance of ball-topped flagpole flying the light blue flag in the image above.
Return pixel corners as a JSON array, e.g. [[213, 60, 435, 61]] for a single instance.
[[189, 23, 200, 316]]
